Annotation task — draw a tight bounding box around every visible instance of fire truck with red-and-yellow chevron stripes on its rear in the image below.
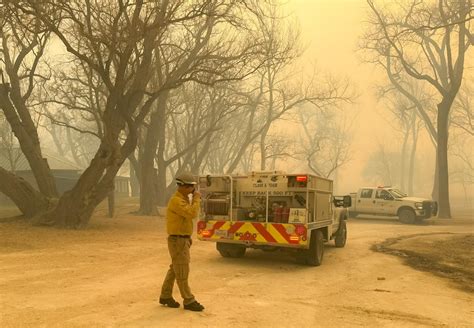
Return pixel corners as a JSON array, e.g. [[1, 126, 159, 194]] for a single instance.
[[197, 171, 351, 266]]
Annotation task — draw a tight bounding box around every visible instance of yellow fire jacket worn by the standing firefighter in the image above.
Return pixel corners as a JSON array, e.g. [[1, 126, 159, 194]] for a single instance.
[[166, 191, 201, 235]]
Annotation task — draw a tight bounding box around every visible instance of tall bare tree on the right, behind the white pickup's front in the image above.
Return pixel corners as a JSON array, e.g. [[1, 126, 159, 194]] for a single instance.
[[367, 0, 473, 218]]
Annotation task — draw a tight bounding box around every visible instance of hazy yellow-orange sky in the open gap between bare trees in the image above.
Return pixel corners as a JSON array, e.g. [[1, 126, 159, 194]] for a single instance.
[[286, 0, 434, 193]]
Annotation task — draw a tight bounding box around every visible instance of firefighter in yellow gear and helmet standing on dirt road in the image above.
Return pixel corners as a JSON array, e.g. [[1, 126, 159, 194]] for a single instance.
[[160, 172, 204, 311]]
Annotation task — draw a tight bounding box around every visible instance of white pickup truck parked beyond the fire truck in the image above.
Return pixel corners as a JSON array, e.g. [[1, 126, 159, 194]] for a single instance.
[[349, 187, 438, 223]]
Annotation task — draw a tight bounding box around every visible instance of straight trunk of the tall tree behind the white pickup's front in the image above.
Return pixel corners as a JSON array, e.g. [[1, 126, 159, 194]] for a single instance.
[[437, 97, 452, 219]]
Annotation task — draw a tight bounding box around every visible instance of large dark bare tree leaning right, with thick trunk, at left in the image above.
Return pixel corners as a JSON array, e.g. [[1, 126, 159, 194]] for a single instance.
[[7, 0, 183, 227]]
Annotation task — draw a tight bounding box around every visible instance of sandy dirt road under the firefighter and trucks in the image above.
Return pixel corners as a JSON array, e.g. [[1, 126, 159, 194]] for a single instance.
[[0, 208, 474, 327]]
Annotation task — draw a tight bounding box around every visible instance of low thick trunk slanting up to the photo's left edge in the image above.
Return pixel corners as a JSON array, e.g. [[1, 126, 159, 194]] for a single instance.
[[0, 167, 49, 218]]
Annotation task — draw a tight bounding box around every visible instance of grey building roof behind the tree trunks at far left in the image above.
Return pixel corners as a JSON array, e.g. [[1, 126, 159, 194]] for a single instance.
[[0, 148, 83, 171]]
